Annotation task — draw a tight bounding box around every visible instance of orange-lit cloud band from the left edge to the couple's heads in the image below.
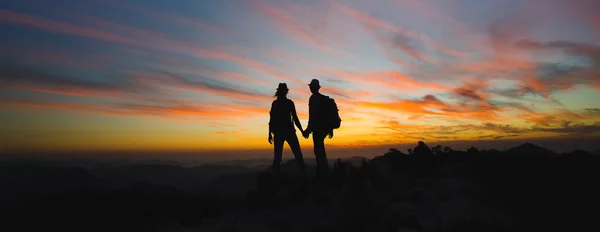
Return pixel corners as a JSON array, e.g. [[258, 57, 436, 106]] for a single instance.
[[0, 64, 271, 119]]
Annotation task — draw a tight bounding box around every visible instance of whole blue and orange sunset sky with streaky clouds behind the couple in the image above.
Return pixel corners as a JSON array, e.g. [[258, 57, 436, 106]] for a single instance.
[[0, 0, 600, 154]]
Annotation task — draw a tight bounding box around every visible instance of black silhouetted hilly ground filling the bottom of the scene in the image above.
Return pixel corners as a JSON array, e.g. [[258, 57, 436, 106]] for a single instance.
[[0, 144, 600, 231]]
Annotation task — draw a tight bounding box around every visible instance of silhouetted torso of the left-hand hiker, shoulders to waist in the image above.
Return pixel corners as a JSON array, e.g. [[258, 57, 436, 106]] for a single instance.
[[270, 98, 296, 132]]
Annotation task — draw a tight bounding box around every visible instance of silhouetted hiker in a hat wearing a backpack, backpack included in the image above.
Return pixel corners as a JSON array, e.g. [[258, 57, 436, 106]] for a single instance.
[[302, 79, 341, 180]]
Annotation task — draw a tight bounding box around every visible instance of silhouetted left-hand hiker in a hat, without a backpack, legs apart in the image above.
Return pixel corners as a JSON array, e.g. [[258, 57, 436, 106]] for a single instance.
[[269, 83, 305, 175]]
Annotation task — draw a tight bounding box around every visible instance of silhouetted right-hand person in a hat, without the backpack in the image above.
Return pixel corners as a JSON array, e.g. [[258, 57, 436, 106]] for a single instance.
[[302, 79, 333, 180]]
